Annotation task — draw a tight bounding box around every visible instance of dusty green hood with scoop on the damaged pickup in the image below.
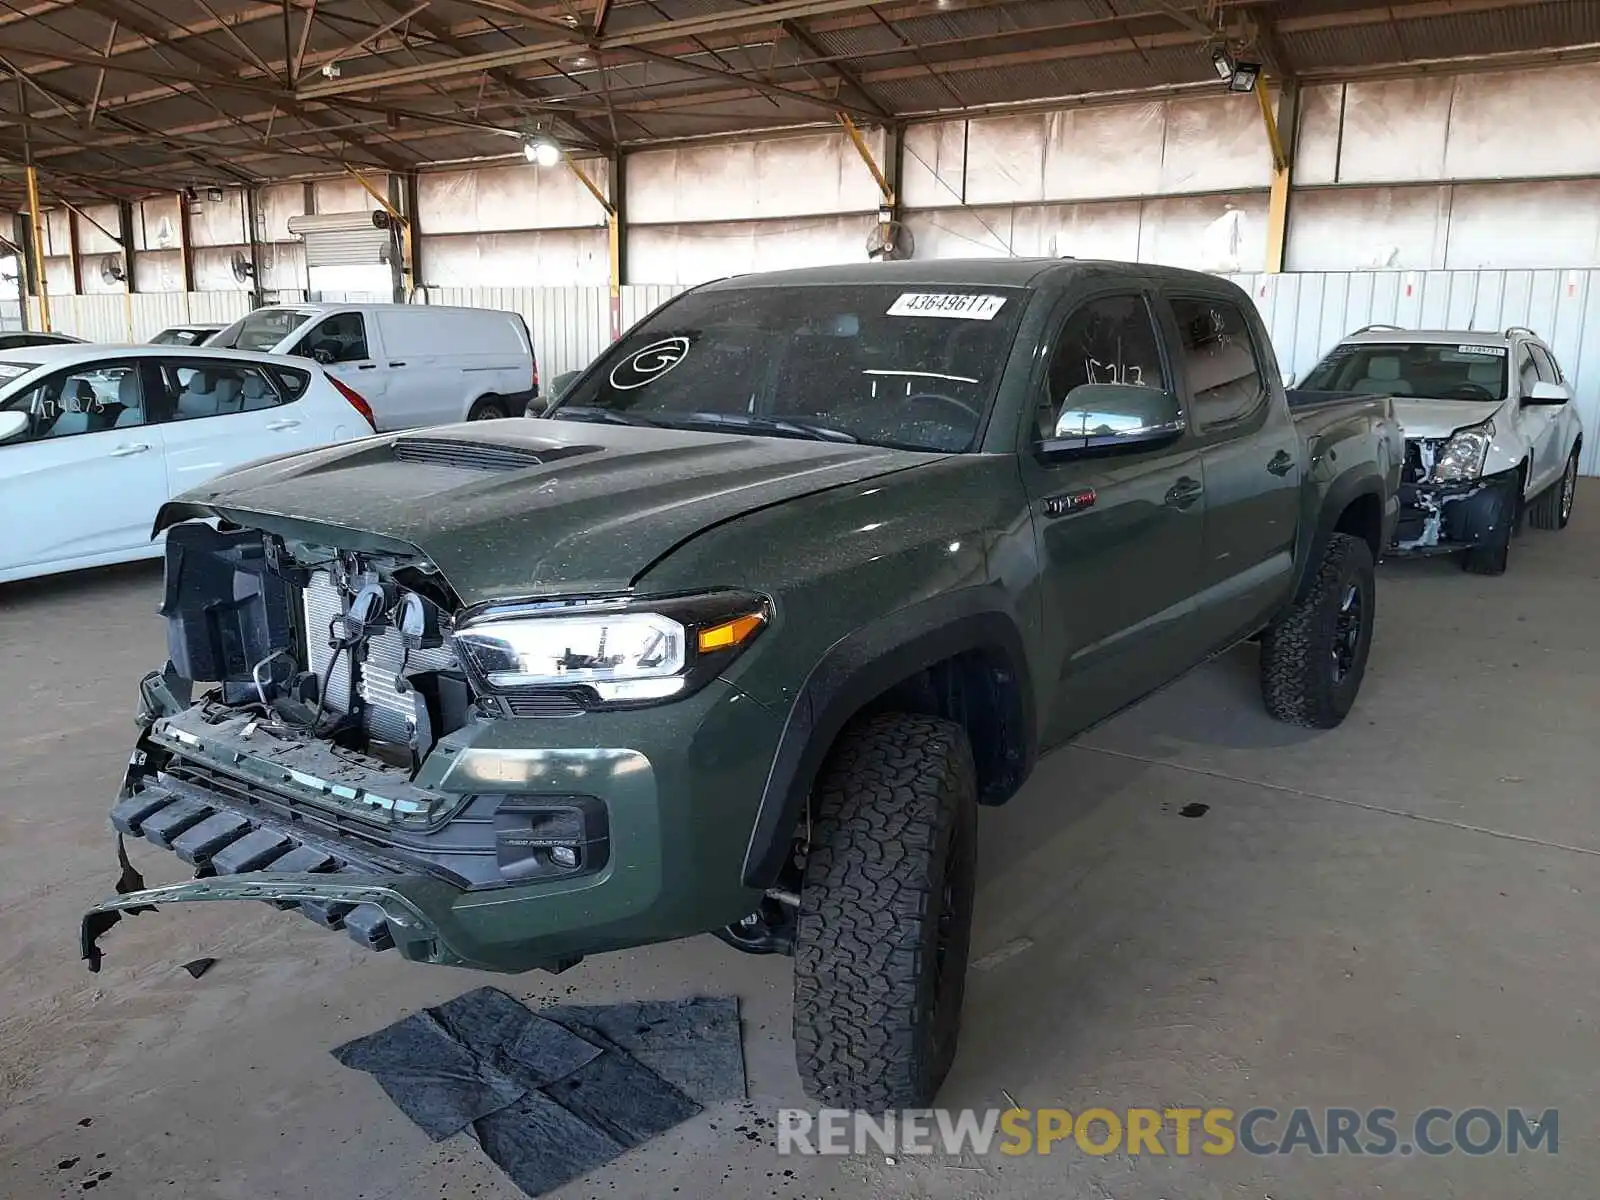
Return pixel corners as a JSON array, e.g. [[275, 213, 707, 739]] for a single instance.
[[157, 418, 946, 605]]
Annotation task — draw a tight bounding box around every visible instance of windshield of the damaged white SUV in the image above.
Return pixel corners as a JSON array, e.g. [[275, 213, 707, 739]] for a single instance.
[[1301, 342, 1506, 400]]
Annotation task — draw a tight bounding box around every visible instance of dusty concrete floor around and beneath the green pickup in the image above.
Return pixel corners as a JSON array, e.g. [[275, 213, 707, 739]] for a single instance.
[[0, 480, 1600, 1200]]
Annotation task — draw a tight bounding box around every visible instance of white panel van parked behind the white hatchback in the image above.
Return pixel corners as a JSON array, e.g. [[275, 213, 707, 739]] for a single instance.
[[206, 304, 539, 430]]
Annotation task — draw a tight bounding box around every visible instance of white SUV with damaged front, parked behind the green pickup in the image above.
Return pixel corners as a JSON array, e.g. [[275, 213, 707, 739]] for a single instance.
[[1301, 325, 1584, 574]]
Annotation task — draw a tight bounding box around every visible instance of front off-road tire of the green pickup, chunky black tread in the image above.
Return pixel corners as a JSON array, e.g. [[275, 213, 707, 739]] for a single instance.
[[794, 712, 978, 1112]]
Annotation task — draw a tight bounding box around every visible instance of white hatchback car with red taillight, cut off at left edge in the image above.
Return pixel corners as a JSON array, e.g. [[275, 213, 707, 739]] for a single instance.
[[0, 344, 373, 582]]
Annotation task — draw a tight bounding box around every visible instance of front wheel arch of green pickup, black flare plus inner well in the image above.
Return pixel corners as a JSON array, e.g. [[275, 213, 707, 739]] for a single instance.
[[744, 589, 1037, 886]]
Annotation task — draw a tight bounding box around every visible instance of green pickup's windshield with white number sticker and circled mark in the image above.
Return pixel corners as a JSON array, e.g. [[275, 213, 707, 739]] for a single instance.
[[550, 283, 1027, 451]]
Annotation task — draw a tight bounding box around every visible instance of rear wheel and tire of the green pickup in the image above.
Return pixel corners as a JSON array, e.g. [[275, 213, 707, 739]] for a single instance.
[[1261, 533, 1376, 730]]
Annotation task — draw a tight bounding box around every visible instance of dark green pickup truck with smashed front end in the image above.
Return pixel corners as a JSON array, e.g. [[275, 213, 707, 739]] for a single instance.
[[82, 259, 1403, 1109]]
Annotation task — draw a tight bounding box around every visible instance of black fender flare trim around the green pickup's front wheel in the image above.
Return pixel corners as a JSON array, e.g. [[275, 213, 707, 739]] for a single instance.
[[742, 587, 1038, 888]]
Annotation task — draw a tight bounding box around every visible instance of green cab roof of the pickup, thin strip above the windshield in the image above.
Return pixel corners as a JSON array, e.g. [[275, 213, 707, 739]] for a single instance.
[[706, 258, 1232, 290]]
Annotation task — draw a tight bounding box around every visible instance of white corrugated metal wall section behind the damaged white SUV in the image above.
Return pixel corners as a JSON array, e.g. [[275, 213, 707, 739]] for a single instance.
[[1232, 270, 1600, 475]]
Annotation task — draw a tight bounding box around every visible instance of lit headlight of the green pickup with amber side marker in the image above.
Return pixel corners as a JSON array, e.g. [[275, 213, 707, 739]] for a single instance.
[[454, 592, 771, 709]]
